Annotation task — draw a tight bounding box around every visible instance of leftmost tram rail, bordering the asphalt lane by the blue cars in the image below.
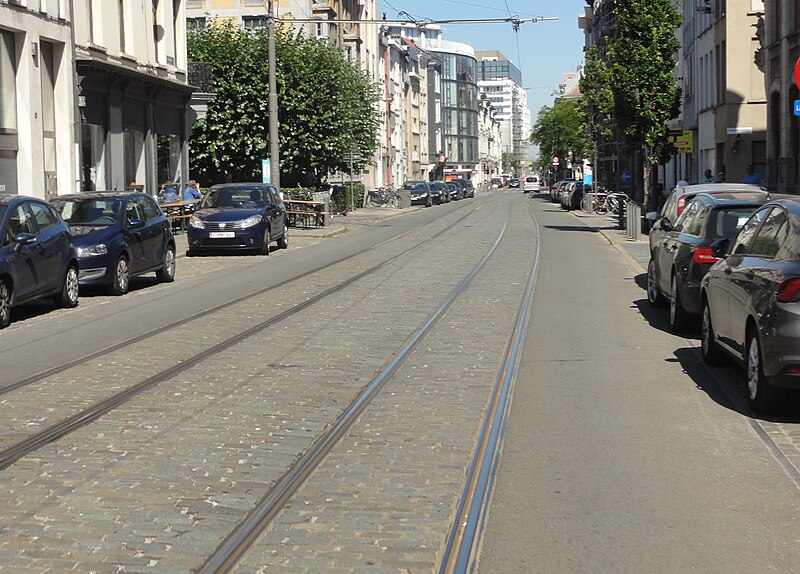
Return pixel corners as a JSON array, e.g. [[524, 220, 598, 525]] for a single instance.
[[0, 200, 484, 396]]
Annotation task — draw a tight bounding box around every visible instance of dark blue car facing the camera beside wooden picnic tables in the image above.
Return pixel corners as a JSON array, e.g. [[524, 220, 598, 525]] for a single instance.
[[186, 183, 289, 256]]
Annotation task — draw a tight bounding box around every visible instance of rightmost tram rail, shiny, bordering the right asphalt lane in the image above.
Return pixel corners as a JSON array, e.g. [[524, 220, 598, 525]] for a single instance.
[[439, 196, 541, 574]]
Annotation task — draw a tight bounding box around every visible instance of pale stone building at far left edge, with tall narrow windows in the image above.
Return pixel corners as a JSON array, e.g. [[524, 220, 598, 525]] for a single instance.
[[0, 0, 79, 199]]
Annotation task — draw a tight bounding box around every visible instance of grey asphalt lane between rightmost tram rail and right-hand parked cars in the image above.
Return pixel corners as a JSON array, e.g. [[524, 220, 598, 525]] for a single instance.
[[480, 195, 800, 573]]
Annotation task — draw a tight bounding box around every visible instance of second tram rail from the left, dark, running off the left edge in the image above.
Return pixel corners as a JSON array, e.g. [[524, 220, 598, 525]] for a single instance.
[[0, 202, 482, 470]]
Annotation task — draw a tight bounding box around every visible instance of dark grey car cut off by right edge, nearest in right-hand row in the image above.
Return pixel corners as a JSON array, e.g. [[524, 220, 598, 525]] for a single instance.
[[701, 197, 800, 414]]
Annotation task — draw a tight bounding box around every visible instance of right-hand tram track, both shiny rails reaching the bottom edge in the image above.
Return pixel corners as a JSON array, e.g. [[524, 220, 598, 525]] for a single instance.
[[197, 199, 540, 574]]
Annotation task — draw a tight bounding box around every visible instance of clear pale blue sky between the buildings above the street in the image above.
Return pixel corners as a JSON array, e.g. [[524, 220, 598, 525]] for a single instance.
[[378, 0, 586, 158]]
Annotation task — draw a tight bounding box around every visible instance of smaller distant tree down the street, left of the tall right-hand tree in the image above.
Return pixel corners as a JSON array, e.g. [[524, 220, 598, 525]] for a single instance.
[[531, 98, 591, 168]]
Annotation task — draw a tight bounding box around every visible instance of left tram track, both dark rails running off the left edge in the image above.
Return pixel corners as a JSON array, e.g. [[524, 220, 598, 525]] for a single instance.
[[0, 205, 483, 470]]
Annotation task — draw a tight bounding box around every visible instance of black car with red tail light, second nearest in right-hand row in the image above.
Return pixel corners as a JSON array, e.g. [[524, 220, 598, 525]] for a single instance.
[[647, 191, 768, 331]]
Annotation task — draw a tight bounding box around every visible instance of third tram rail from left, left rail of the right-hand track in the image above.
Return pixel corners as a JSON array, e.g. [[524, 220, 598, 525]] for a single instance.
[[197, 215, 508, 574]]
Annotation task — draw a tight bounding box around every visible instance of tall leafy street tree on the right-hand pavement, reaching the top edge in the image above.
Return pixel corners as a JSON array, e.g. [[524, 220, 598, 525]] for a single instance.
[[581, 0, 682, 203]]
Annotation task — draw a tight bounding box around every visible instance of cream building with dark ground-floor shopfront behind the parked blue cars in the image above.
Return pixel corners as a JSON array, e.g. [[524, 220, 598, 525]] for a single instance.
[[73, 0, 193, 192]]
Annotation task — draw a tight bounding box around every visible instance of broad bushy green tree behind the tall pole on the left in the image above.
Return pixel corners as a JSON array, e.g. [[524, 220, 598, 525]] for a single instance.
[[188, 22, 379, 185]]
